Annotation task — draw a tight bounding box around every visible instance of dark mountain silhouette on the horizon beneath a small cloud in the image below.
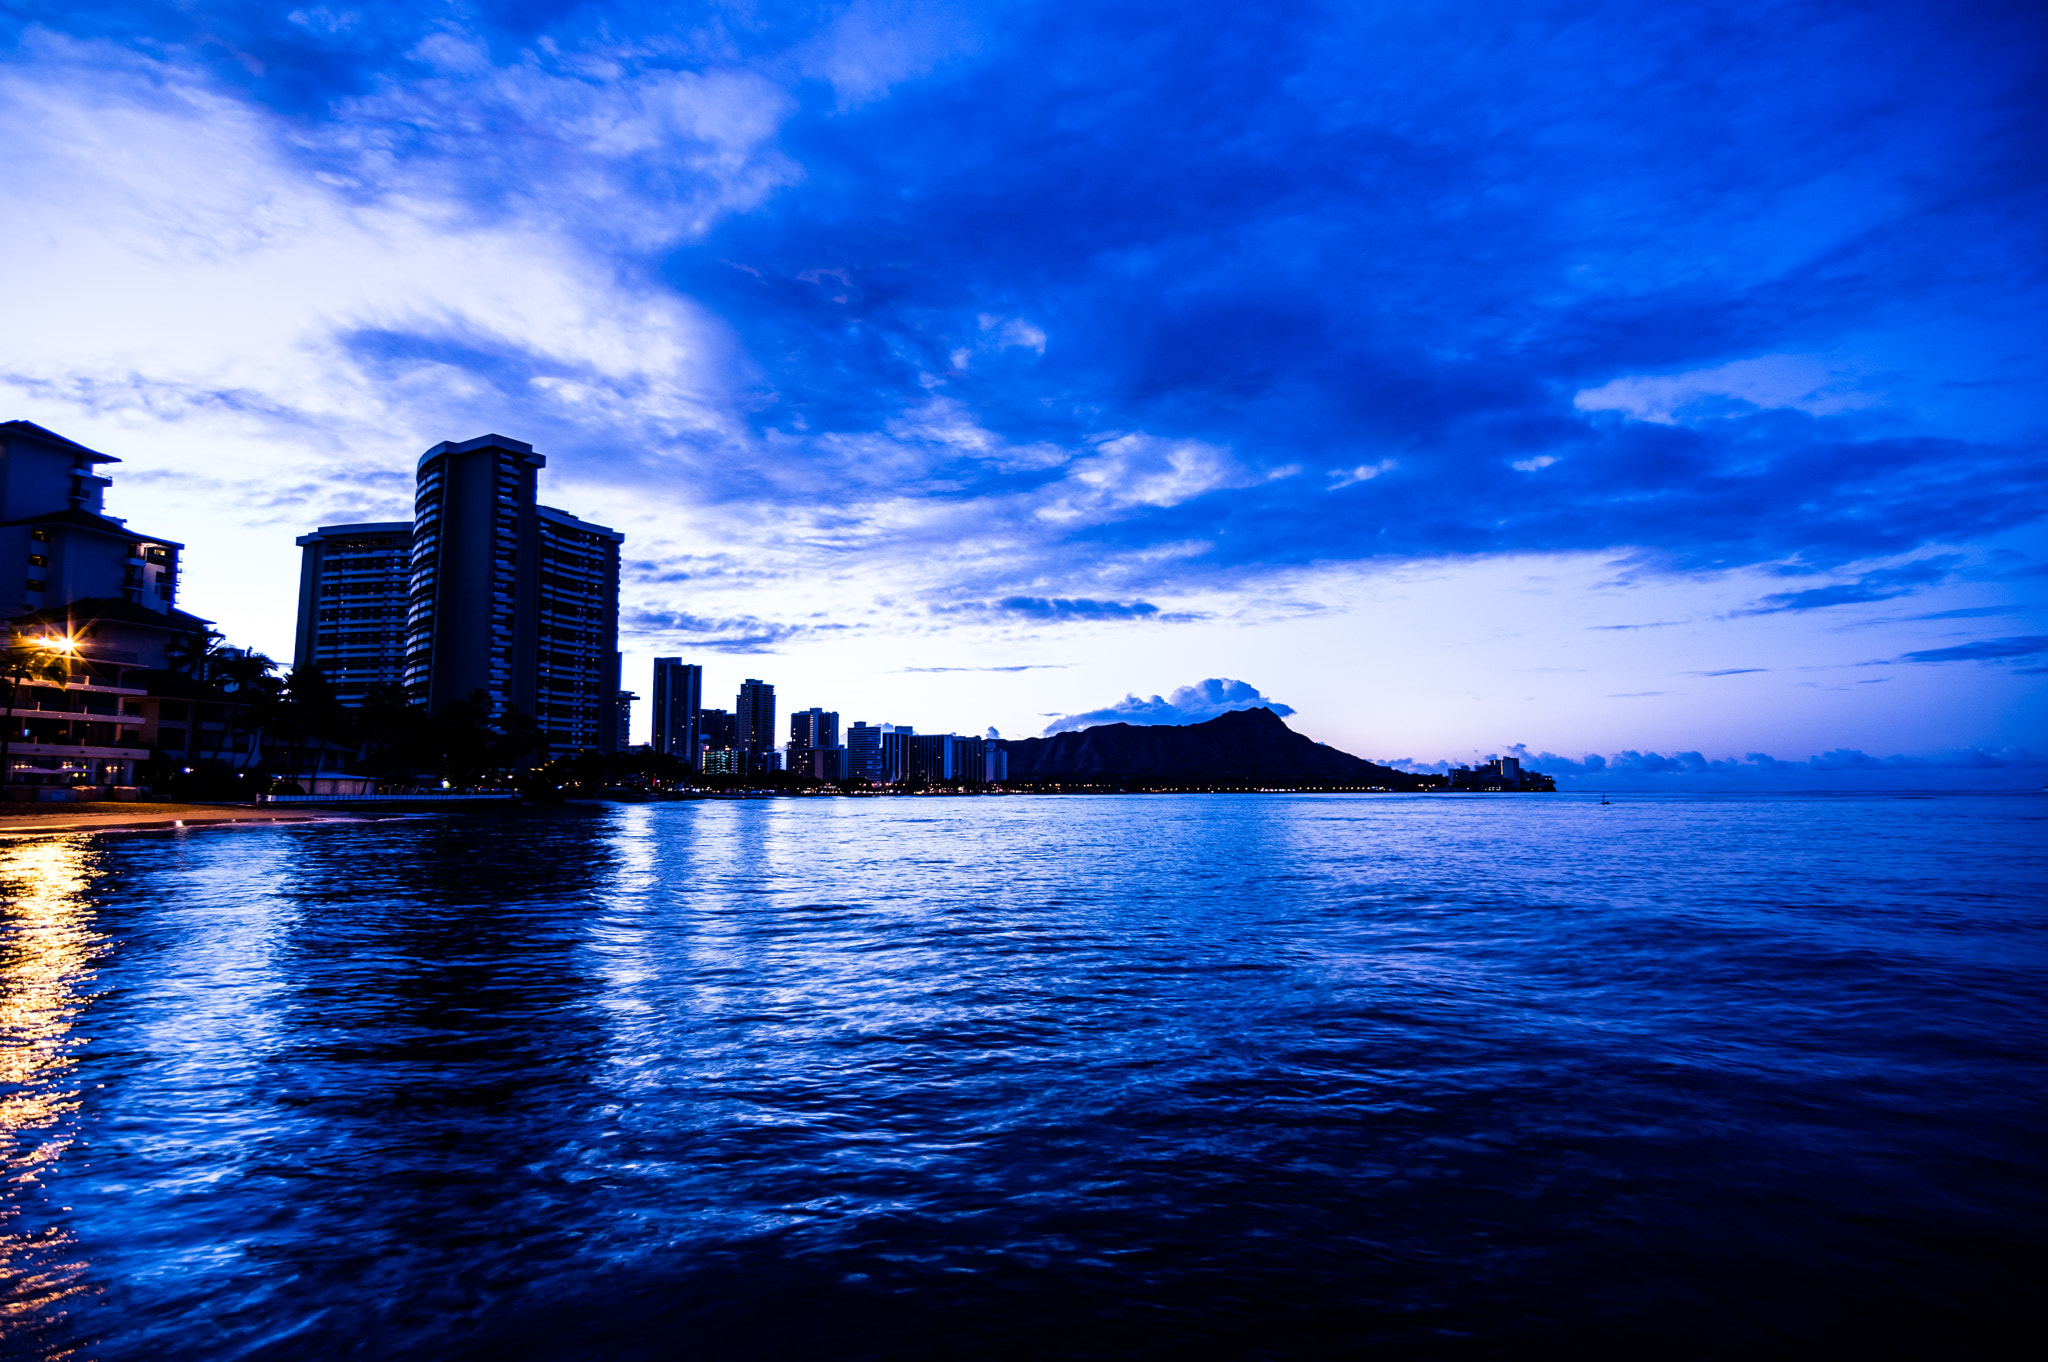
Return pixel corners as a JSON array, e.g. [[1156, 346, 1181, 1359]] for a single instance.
[[1004, 707, 1419, 791]]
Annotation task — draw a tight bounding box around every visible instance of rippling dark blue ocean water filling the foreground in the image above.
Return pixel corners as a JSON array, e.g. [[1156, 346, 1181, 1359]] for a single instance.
[[0, 795, 2048, 1360]]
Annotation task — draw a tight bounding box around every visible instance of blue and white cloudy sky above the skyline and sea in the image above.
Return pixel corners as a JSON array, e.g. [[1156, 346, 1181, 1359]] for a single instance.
[[0, 0, 2048, 789]]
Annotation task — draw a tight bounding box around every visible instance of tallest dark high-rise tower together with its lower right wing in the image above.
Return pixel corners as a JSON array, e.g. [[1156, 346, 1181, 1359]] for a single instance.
[[406, 434, 625, 752]]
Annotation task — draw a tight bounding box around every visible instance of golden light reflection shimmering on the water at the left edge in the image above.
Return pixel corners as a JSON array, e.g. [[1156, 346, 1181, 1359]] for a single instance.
[[0, 836, 106, 1356]]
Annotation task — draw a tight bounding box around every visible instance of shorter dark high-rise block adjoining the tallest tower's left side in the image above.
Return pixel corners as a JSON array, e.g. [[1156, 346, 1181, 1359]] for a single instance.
[[291, 520, 412, 705]]
